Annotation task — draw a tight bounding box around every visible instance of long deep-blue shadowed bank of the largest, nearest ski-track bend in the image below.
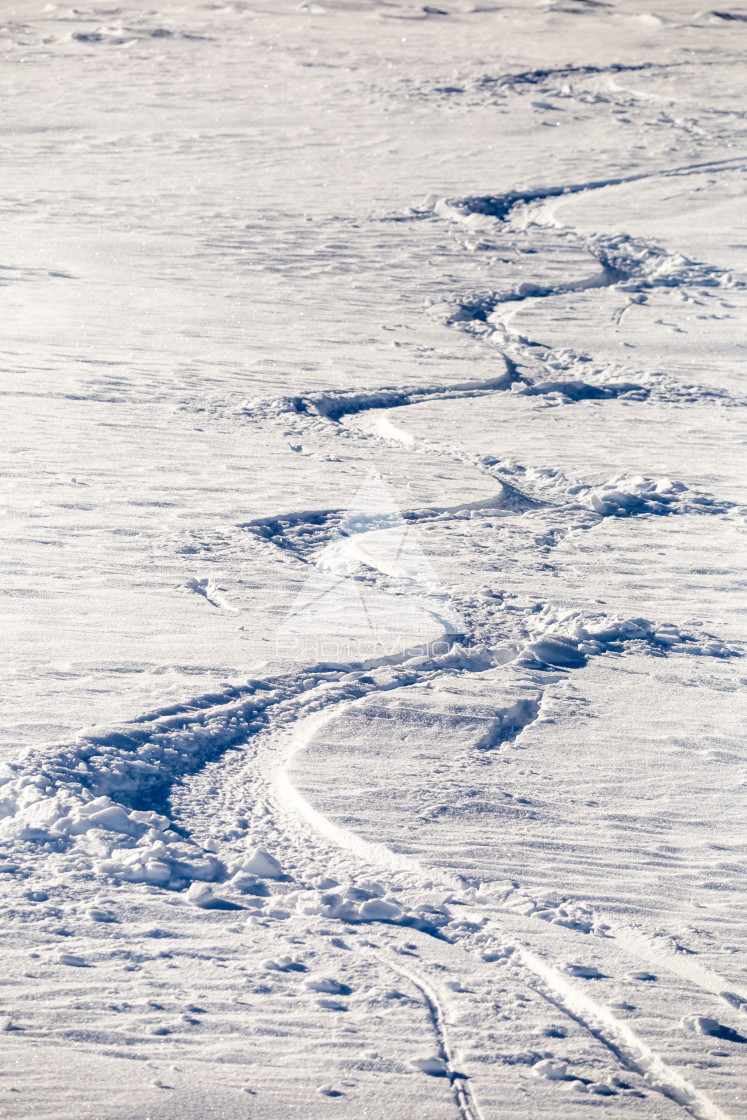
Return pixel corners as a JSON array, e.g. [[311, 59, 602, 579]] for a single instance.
[[10, 606, 735, 838]]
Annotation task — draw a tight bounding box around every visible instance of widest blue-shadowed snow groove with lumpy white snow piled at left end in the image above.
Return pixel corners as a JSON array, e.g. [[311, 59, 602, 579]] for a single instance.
[[0, 605, 734, 889]]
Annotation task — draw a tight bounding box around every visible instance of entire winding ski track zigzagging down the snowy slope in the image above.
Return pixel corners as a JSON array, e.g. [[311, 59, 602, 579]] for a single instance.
[[0, 106, 747, 1120]]
